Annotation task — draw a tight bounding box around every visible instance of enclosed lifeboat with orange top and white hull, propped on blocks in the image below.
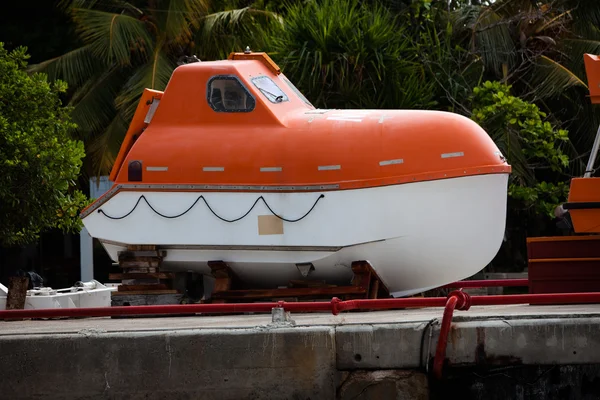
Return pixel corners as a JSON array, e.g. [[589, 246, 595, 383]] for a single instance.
[[82, 52, 510, 296]]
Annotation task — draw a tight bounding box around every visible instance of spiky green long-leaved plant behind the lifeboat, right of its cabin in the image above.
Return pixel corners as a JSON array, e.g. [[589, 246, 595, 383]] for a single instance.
[[271, 0, 435, 108]]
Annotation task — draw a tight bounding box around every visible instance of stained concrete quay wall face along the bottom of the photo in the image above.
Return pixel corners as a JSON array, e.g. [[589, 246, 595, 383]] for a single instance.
[[0, 315, 600, 400]]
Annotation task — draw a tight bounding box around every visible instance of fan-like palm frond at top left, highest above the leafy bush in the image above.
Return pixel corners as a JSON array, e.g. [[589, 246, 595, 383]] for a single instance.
[[72, 8, 153, 65]]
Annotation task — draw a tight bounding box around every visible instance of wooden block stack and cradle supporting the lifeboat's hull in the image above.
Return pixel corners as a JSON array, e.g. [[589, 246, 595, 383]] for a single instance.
[[109, 246, 390, 306]]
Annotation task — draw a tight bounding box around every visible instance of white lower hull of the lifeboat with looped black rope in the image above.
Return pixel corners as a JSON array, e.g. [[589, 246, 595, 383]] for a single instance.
[[83, 174, 508, 296]]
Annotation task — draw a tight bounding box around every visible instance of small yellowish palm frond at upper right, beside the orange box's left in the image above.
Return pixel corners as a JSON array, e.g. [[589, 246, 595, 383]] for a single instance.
[[532, 56, 587, 99]]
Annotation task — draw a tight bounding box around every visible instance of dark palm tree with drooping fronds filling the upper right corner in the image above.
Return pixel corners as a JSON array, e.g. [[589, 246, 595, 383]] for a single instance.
[[443, 0, 600, 175]]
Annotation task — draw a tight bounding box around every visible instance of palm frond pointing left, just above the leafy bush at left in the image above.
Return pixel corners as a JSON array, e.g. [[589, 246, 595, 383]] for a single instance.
[[28, 45, 106, 86]]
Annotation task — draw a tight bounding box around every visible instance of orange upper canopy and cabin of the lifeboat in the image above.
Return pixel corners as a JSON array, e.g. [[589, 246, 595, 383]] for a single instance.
[[90, 53, 510, 214]]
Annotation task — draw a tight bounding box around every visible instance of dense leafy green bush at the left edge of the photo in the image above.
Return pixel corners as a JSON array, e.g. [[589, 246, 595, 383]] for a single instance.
[[0, 42, 88, 246]]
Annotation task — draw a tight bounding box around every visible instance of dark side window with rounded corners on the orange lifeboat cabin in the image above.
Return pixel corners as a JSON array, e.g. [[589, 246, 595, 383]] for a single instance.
[[207, 75, 256, 112]]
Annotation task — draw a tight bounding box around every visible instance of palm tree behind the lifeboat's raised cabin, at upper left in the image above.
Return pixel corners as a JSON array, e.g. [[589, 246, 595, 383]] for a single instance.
[[31, 0, 281, 175]]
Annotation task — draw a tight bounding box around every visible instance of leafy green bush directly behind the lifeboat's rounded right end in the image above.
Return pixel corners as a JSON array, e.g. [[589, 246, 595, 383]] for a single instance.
[[471, 81, 569, 217]]
